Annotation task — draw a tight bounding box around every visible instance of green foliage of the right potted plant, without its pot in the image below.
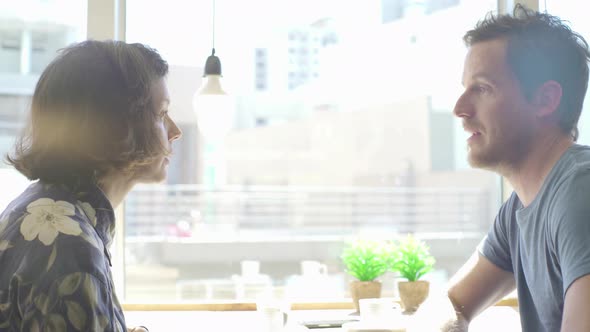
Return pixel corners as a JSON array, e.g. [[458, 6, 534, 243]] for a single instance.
[[391, 235, 435, 281]]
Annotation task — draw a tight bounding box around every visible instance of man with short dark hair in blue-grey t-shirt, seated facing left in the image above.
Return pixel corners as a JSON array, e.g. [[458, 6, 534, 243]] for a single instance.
[[434, 5, 590, 332]]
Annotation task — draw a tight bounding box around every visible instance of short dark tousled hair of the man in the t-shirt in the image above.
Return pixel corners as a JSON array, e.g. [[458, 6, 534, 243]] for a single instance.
[[463, 4, 590, 140]]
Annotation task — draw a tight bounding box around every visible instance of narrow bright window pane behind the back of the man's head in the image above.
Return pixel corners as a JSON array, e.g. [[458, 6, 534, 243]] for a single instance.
[[544, 0, 590, 145]]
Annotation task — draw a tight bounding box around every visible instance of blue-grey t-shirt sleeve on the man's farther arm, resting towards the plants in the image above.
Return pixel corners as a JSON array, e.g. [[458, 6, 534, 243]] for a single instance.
[[478, 193, 517, 273]]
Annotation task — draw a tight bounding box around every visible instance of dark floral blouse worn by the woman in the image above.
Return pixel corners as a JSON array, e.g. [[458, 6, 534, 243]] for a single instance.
[[0, 182, 126, 332]]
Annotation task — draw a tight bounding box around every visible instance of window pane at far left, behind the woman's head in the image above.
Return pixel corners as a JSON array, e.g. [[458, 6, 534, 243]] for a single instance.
[[0, 0, 86, 210]]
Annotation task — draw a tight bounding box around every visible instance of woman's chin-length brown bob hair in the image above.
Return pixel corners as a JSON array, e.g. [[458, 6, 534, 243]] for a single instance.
[[6, 40, 169, 183]]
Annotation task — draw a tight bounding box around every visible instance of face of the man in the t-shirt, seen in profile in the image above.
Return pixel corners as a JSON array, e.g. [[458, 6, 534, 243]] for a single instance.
[[454, 39, 535, 171]]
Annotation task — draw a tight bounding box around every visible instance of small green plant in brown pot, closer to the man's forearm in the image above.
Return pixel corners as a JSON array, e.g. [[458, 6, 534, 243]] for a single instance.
[[391, 235, 435, 312]]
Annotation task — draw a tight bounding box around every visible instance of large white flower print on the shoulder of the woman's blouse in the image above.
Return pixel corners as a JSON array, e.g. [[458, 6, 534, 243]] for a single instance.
[[20, 198, 82, 246]]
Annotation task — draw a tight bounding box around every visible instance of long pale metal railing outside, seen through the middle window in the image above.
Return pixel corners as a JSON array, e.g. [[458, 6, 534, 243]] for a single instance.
[[125, 185, 493, 239]]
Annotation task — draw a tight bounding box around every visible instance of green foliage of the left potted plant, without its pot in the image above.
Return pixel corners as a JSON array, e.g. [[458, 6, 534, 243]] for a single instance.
[[341, 240, 392, 281]]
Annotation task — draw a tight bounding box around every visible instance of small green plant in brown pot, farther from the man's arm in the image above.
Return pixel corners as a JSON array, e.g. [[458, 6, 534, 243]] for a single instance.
[[341, 240, 392, 312]]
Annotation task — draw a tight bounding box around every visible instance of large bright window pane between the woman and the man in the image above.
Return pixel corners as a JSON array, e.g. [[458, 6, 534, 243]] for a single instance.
[[125, 0, 500, 302]]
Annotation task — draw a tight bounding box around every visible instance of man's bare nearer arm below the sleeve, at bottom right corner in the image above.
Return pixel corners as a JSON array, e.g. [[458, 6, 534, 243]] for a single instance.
[[561, 275, 590, 332]]
